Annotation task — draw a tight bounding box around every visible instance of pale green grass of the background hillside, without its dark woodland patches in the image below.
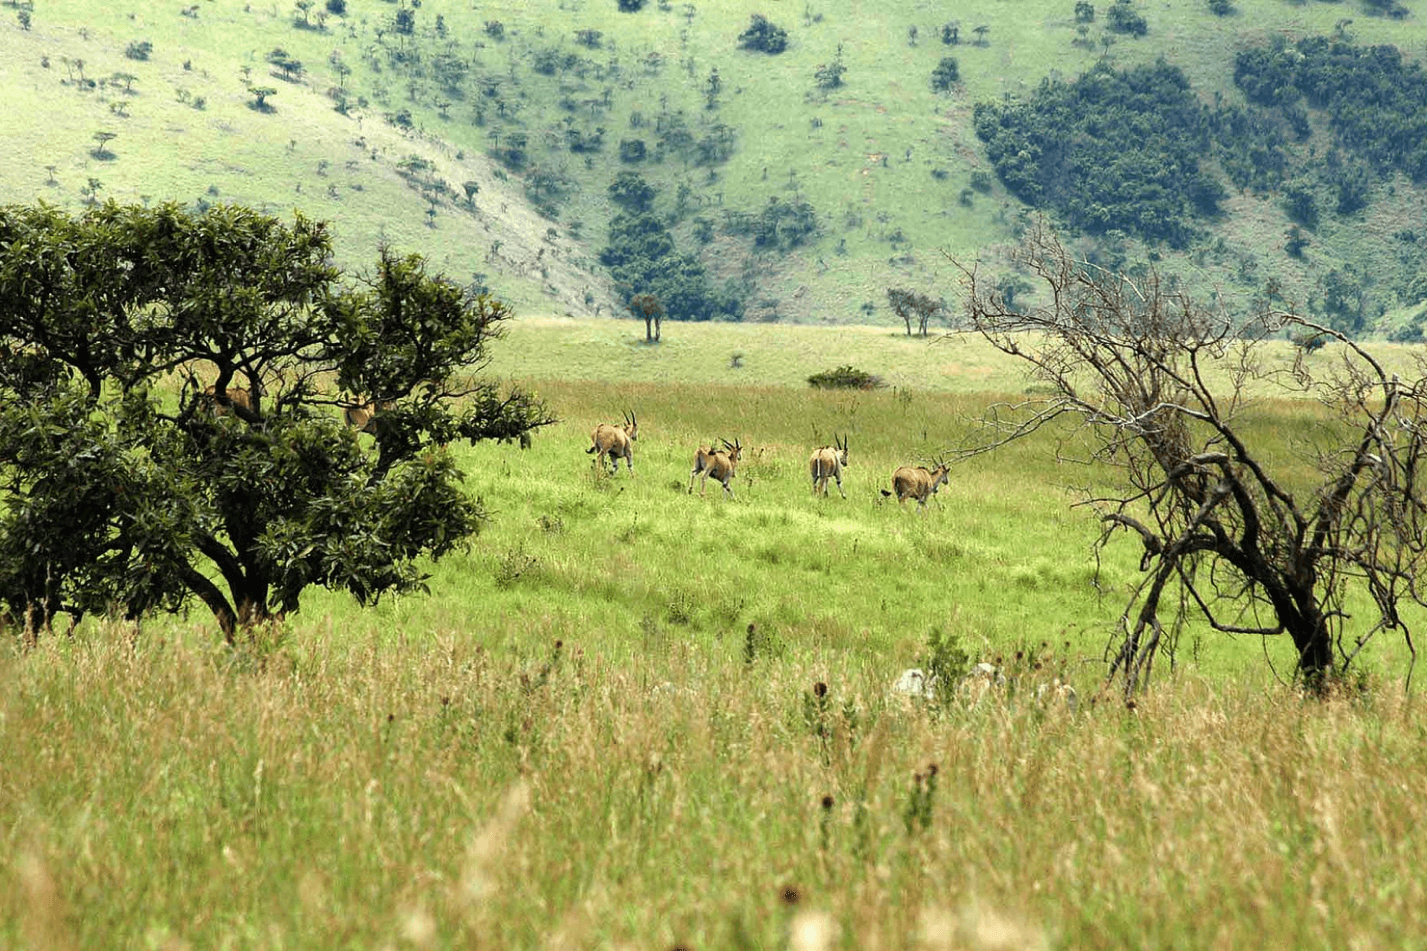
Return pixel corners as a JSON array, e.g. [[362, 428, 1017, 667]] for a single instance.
[[0, 0, 1421, 329]]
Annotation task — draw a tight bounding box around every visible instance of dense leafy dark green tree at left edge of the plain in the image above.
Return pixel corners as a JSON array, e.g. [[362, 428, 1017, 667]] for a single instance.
[[0, 203, 552, 641]]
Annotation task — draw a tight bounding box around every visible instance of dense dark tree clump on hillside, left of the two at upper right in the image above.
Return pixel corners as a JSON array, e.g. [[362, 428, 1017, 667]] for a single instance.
[[975, 61, 1224, 247]]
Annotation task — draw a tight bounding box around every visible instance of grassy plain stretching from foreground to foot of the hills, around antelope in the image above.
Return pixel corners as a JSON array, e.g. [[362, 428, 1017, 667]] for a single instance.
[[0, 317, 1427, 948]]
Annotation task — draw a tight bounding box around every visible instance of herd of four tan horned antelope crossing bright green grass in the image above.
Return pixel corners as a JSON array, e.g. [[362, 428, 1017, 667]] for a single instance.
[[585, 410, 952, 513]]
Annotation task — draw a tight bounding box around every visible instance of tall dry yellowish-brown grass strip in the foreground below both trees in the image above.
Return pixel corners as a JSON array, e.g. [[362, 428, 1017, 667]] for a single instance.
[[0, 630, 1427, 948]]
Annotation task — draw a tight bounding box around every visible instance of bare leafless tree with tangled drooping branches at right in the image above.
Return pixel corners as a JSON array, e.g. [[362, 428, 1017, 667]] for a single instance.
[[962, 226, 1427, 693]]
